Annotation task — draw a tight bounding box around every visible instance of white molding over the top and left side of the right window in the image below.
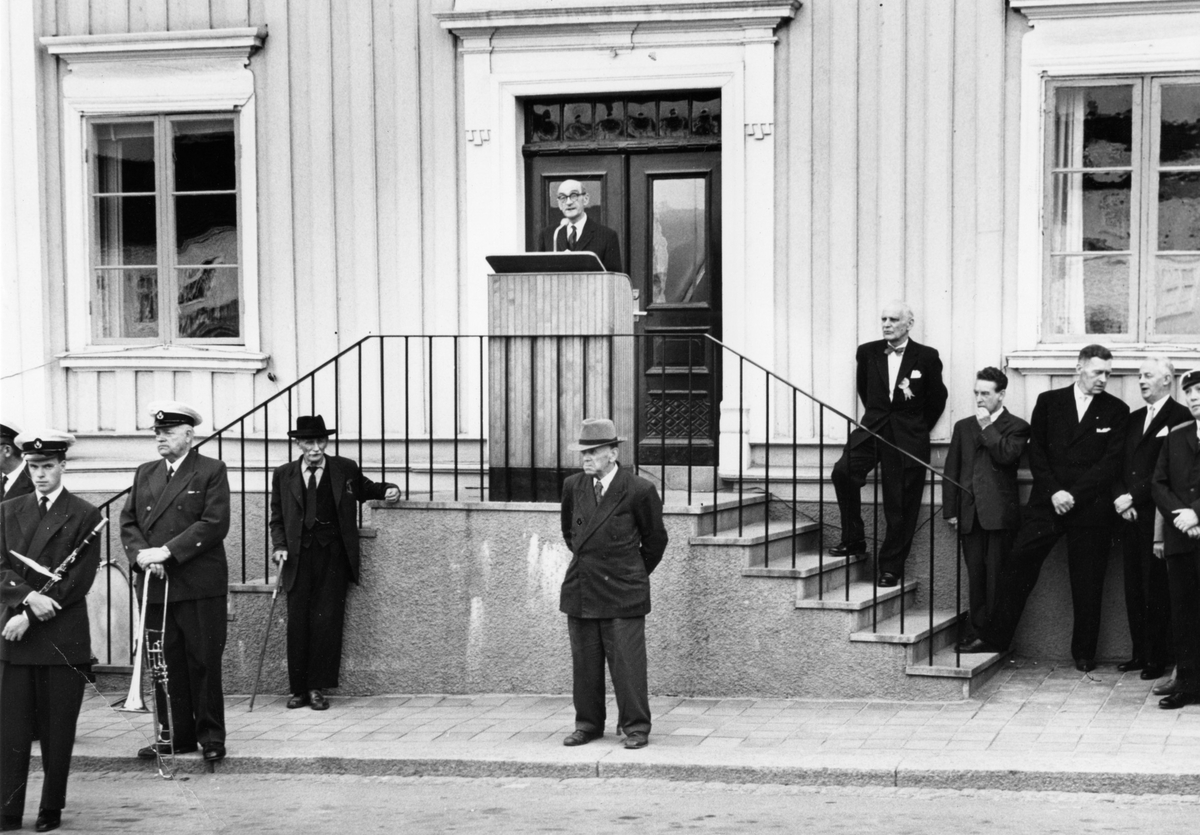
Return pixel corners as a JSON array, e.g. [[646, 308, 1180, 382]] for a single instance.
[[1009, 11, 1200, 352]]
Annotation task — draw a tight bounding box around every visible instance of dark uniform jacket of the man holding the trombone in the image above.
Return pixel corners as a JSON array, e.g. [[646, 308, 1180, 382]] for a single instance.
[[121, 450, 229, 603]]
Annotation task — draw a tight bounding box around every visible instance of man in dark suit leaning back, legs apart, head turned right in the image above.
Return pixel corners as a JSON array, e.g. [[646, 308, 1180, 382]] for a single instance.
[[961, 344, 1129, 672]]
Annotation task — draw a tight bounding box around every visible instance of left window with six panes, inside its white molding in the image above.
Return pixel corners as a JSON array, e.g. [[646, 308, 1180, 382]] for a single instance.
[[89, 114, 244, 344]]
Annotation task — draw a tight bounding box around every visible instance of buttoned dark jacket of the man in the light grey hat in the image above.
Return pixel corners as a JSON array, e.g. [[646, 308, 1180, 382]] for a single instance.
[[559, 467, 667, 618]]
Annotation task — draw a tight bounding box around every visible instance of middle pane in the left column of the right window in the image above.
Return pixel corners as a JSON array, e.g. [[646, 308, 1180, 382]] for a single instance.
[[1050, 173, 1133, 252]]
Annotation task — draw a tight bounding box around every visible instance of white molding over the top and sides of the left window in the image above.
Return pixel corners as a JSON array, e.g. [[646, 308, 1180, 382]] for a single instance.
[[41, 26, 266, 356]]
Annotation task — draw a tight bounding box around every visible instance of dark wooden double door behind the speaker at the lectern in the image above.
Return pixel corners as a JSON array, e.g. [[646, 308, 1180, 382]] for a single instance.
[[527, 149, 721, 467]]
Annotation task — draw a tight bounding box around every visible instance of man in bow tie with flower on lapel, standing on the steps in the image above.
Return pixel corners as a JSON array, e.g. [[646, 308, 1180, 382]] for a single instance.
[[829, 301, 947, 587]]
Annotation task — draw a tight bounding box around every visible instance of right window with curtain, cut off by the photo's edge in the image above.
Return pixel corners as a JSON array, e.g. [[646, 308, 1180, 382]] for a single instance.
[[1042, 76, 1200, 342]]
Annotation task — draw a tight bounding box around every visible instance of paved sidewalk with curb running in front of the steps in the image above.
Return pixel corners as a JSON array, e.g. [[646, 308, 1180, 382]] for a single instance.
[[63, 660, 1200, 794]]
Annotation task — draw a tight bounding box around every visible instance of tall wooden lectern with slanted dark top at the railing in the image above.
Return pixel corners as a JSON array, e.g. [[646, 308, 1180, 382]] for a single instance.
[[487, 252, 635, 501]]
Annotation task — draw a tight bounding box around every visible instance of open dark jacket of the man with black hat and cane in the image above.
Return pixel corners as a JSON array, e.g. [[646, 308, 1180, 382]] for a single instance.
[[271, 455, 396, 591]]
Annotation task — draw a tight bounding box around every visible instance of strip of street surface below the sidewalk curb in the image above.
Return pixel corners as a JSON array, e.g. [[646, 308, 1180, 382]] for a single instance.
[[28, 773, 1200, 835]]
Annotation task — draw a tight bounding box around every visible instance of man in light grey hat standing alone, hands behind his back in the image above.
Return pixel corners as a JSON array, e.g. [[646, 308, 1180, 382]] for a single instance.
[[559, 420, 667, 749]]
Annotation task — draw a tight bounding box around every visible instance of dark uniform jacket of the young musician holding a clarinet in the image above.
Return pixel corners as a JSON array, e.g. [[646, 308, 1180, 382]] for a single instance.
[[0, 489, 103, 665]]
